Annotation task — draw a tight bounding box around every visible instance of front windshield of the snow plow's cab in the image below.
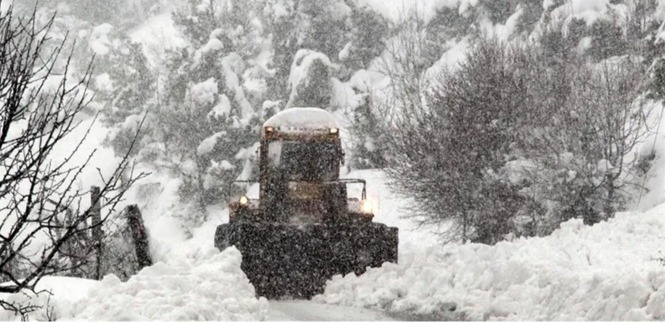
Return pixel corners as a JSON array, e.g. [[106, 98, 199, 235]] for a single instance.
[[268, 141, 339, 181]]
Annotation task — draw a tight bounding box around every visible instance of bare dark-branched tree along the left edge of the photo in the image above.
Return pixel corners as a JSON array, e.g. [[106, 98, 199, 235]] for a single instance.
[[0, 3, 145, 315]]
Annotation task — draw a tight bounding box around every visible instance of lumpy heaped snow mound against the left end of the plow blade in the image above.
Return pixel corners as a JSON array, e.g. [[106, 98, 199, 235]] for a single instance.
[[74, 248, 268, 321]]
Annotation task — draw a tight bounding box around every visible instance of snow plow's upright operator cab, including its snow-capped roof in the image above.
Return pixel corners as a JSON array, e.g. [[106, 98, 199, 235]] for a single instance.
[[260, 108, 347, 224]]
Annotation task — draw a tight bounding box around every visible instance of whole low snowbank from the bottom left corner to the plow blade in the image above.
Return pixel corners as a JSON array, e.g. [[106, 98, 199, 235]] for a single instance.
[[0, 248, 268, 321]]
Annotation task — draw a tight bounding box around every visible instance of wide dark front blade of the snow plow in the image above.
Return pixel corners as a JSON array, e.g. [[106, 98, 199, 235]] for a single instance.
[[215, 221, 398, 299]]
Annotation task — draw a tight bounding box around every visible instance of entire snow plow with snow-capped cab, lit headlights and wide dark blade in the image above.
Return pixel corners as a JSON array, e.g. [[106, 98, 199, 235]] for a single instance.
[[215, 108, 398, 299]]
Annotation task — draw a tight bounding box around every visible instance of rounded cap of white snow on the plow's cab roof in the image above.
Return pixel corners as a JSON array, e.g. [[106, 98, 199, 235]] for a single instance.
[[263, 107, 338, 130]]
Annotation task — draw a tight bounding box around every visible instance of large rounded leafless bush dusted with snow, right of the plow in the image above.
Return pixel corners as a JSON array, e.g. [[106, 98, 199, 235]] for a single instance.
[[388, 40, 653, 243]]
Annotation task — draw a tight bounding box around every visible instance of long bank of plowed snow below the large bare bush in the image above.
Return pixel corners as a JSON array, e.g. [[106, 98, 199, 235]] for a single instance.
[[315, 206, 665, 320]]
